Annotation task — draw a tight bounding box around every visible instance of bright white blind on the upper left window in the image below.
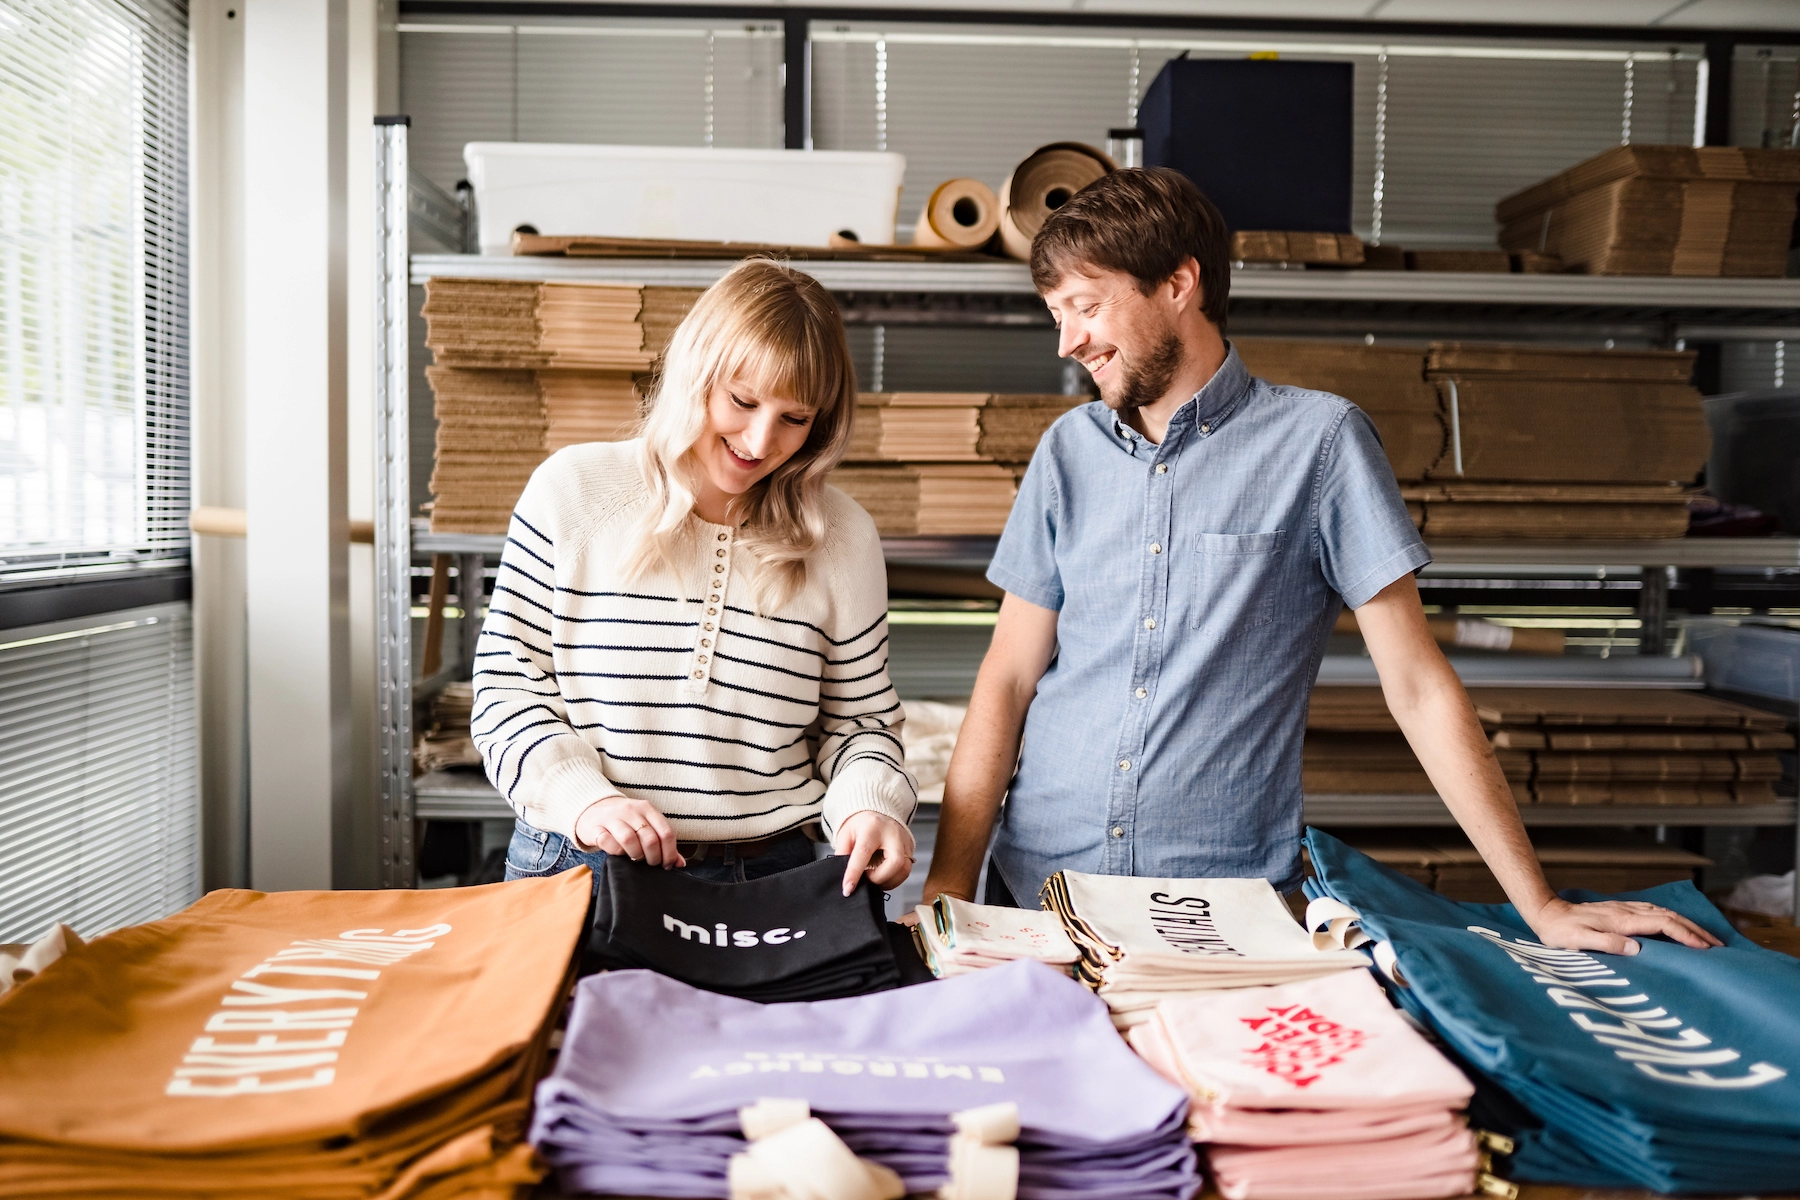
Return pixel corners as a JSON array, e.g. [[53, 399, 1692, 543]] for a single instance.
[[0, 0, 189, 578]]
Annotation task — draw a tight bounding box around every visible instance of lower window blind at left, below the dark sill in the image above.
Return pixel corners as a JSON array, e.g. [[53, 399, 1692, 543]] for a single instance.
[[0, 604, 200, 943]]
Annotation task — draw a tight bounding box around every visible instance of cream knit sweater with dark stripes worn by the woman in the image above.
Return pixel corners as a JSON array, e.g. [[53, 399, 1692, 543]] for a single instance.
[[470, 441, 918, 842]]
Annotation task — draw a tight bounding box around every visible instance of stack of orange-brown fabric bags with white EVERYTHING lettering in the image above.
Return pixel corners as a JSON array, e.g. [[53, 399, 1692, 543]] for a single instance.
[[0, 869, 590, 1200]]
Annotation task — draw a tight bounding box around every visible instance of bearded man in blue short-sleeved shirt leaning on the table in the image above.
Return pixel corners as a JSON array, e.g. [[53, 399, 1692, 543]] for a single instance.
[[925, 169, 1717, 954]]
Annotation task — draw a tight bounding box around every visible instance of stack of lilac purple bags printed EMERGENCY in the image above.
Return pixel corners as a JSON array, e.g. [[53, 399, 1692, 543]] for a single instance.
[[531, 963, 1199, 1200]]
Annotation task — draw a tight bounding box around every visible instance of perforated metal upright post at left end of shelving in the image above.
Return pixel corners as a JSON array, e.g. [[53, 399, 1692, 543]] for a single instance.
[[374, 117, 418, 887]]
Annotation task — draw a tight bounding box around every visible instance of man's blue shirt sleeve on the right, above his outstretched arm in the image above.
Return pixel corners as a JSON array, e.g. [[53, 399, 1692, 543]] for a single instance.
[[1317, 407, 1431, 608]]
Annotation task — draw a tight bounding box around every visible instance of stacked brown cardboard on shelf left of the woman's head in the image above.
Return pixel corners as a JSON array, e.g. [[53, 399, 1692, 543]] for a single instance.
[[423, 279, 700, 533]]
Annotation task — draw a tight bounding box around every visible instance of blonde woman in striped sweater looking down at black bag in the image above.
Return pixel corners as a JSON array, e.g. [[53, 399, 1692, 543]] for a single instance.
[[472, 259, 918, 894]]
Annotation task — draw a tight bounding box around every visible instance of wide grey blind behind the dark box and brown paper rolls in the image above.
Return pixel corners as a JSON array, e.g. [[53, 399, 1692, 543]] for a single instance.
[[812, 22, 1701, 248]]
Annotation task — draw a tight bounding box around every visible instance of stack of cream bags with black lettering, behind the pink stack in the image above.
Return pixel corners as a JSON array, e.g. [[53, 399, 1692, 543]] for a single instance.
[[1040, 871, 1368, 1027]]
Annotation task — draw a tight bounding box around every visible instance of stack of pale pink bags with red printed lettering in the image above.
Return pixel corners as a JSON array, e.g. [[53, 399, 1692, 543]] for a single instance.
[[1127, 972, 1478, 1200]]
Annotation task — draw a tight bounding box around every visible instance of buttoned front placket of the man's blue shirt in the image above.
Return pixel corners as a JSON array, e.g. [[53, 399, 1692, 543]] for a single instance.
[[1102, 423, 1183, 874]]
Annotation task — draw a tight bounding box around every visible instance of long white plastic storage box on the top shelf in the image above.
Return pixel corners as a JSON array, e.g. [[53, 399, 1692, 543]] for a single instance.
[[463, 142, 905, 254]]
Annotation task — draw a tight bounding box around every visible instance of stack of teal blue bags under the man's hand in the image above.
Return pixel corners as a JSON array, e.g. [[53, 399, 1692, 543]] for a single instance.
[[1307, 829, 1800, 1193]]
